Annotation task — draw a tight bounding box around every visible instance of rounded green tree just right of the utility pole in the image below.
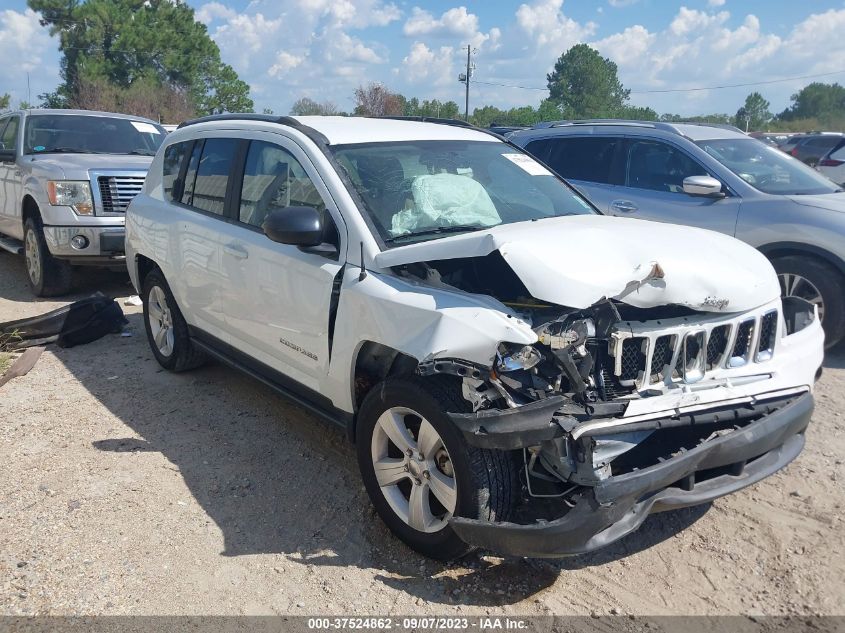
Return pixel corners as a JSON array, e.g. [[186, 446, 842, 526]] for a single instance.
[[546, 44, 630, 119]]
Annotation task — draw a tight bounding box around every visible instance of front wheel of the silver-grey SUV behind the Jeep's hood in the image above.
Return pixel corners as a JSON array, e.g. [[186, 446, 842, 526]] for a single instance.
[[772, 256, 845, 349]]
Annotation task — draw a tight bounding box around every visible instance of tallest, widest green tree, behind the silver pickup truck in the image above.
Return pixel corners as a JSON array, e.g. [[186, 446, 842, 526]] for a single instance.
[[27, 0, 253, 113]]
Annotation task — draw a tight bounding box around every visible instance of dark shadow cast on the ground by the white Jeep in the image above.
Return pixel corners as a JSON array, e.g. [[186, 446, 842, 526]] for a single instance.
[[41, 314, 706, 606]]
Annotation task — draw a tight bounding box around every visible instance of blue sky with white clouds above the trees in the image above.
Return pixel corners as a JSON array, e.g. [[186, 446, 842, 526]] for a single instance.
[[0, 0, 845, 115]]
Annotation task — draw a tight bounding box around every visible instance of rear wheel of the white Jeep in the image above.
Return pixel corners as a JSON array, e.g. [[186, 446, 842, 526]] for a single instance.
[[141, 269, 206, 371]]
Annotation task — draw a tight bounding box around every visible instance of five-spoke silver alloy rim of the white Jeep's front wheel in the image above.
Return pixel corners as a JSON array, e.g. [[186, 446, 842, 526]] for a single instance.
[[371, 407, 458, 533]]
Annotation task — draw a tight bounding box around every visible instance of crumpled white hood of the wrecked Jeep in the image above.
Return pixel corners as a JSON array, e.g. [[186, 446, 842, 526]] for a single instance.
[[374, 215, 780, 312]]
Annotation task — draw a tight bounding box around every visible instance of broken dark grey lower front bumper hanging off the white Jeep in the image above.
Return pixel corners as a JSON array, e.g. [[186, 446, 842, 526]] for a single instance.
[[450, 393, 813, 558]]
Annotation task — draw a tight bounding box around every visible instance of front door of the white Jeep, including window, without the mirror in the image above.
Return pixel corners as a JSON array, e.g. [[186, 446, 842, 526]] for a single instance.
[[222, 133, 346, 390]]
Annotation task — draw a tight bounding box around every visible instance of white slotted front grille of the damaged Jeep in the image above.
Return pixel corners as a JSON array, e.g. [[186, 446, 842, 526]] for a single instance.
[[611, 308, 779, 389]]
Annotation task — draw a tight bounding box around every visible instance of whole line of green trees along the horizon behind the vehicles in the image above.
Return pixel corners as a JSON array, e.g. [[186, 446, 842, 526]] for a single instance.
[[0, 5, 845, 131]]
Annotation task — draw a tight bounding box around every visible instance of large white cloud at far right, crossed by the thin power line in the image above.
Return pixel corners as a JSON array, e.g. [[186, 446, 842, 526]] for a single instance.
[[592, 3, 845, 114]]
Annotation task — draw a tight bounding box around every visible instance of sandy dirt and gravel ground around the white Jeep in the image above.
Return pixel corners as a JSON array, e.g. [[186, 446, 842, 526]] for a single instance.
[[0, 252, 845, 615]]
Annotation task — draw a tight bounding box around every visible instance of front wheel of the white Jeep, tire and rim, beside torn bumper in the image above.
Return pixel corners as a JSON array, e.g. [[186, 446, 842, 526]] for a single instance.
[[356, 378, 519, 560]]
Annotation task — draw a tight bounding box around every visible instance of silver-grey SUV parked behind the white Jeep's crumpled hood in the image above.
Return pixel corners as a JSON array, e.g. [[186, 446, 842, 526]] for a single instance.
[[510, 120, 845, 347]]
